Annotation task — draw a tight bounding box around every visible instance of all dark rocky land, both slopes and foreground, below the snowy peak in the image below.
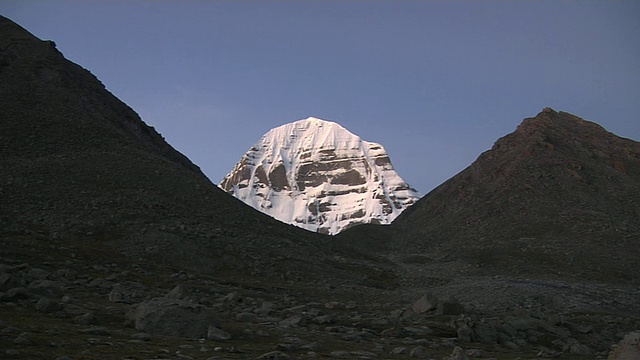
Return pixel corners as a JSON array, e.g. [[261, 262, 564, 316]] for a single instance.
[[0, 17, 640, 359]]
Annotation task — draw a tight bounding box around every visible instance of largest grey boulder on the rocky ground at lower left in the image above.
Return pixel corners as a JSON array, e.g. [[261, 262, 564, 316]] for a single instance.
[[126, 297, 216, 339]]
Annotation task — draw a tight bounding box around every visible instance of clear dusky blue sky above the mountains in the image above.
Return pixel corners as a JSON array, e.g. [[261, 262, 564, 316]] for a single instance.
[[0, 0, 640, 194]]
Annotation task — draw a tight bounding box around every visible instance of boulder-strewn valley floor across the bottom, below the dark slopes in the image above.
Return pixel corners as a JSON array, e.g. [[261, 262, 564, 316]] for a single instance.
[[0, 233, 640, 359]]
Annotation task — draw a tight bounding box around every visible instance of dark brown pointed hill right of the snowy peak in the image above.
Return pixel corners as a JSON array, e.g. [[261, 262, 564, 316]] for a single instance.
[[393, 108, 640, 283]]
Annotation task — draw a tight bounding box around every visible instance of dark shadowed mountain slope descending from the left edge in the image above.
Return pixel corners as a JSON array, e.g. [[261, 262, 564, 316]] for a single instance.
[[0, 17, 380, 279]]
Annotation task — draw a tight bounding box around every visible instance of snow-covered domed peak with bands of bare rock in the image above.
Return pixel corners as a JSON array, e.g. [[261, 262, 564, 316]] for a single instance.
[[220, 117, 419, 234]]
